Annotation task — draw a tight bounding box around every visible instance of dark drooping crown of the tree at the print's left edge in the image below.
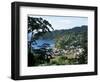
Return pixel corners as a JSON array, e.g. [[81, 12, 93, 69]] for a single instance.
[[28, 17, 54, 50]]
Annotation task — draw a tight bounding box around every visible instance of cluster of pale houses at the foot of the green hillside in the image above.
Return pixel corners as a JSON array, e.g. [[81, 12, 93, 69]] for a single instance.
[[53, 46, 84, 58]]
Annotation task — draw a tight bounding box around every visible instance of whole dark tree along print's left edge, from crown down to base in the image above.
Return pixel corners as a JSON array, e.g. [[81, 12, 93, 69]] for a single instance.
[[28, 17, 54, 66]]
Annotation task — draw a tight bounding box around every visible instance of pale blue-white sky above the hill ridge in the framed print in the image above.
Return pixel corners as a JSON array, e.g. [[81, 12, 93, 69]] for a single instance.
[[29, 15, 88, 30]]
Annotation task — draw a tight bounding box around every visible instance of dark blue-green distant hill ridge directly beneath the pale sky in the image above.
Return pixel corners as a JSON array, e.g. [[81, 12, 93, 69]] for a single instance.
[[41, 25, 88, 39]]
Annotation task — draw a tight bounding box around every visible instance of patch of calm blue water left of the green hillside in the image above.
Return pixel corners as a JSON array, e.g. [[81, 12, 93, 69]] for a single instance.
[[32, 39, 55, 49]]
